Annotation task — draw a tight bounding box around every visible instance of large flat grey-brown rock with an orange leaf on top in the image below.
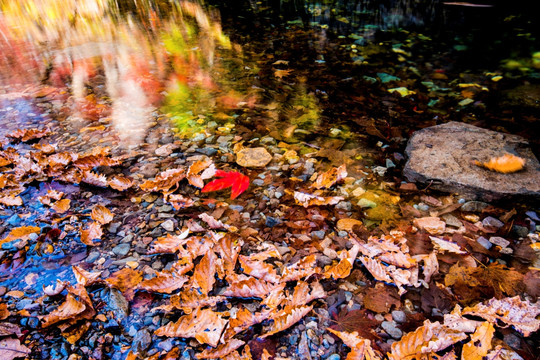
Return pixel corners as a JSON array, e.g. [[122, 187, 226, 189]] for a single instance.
[[403, 122, 540, 201]]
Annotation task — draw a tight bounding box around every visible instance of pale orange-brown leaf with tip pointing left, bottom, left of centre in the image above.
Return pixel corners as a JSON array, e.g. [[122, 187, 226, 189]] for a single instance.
[[155, 309, 227, 347]]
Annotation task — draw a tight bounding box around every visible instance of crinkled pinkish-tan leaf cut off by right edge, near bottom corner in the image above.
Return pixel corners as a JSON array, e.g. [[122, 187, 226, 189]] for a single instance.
[[463, 296, 540, 336]]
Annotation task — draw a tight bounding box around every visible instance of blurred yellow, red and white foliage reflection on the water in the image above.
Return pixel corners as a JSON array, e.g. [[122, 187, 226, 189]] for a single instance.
[[0, 0, 236, 147]]
